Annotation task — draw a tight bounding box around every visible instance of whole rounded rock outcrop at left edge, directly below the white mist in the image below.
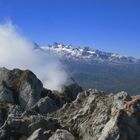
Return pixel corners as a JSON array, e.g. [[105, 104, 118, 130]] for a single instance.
[[0, 68, 43, 110]]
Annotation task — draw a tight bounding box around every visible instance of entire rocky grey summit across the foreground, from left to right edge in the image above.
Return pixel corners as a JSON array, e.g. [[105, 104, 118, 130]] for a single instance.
[[0, 68, 140, 140]]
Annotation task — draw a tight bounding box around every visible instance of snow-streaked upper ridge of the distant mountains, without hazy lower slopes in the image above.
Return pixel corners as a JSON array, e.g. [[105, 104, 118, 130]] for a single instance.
[[41, 43, 139, 63]]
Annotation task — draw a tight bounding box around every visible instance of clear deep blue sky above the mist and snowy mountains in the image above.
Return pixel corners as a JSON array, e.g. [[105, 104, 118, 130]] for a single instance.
[[0, 0, 140, 58]]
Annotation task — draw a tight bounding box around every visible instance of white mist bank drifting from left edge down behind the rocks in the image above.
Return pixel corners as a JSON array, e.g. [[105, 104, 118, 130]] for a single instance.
[[0, 22, 67, 90]]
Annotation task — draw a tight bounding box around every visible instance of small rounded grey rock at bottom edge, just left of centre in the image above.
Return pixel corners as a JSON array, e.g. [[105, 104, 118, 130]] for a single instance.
[[49, 129, 75, 140]]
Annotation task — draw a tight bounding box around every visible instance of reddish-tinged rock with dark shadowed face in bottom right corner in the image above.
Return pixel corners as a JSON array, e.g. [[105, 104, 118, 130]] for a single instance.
[[99, 98, 140, 140]]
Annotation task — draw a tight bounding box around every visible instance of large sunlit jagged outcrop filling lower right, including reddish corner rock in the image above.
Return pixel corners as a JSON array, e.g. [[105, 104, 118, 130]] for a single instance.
[[53, 90, 140, 140]]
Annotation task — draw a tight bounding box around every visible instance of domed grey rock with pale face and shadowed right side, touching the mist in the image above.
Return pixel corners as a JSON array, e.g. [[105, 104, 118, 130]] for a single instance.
[[15, 71, 43, 109]]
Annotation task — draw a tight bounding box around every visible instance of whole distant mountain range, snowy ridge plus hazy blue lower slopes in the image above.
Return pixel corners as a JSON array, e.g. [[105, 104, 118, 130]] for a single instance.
[[39, 43, 140, 94]]
